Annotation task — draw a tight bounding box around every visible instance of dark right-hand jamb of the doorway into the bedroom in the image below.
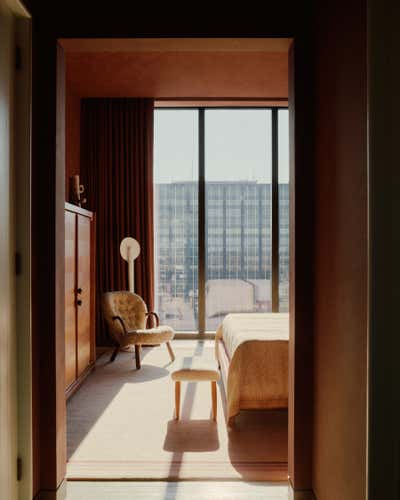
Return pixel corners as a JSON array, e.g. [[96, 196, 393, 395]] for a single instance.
[[288, 37, 314, 492]]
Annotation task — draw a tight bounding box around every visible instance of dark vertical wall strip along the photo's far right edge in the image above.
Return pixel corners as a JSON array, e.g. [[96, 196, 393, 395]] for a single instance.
[[368, 0, 400, 500]]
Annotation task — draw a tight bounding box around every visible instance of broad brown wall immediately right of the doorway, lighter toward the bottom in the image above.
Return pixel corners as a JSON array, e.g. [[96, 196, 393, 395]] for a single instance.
[[313, 0, 368, 500]]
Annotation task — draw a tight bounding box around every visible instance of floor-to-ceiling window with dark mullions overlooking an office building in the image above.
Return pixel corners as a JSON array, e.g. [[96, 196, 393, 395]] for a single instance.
[[154, 108, 289, 333]]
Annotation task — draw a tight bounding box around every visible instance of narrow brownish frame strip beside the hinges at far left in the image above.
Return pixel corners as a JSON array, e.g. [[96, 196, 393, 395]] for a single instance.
[[15, 10, 33, 498]]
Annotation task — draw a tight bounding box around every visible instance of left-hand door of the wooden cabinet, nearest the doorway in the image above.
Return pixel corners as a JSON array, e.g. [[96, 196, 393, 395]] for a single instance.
[[65, 212, 76, 387]]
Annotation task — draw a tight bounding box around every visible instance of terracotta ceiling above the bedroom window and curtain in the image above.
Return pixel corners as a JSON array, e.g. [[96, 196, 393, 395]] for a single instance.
[[59, 38, 290, 100]]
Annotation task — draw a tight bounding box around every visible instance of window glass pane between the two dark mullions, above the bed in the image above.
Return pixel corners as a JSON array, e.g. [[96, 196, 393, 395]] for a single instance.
[[205, 109, 271, 330]]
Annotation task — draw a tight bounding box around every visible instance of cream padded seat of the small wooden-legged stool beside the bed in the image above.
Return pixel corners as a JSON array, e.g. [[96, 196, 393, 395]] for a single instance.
[[171, 356, 220, 382]]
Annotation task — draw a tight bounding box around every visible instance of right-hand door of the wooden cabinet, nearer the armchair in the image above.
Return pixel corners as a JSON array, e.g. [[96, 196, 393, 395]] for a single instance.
[[77, 215, 91, 377]]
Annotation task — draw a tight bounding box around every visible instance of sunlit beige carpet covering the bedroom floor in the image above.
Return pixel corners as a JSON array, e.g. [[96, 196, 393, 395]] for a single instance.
[[67, 340, 287, 481]]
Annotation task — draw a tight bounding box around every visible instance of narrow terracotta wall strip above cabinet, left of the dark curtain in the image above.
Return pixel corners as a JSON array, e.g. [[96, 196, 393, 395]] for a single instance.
[[65, 83, 81, 200]]
